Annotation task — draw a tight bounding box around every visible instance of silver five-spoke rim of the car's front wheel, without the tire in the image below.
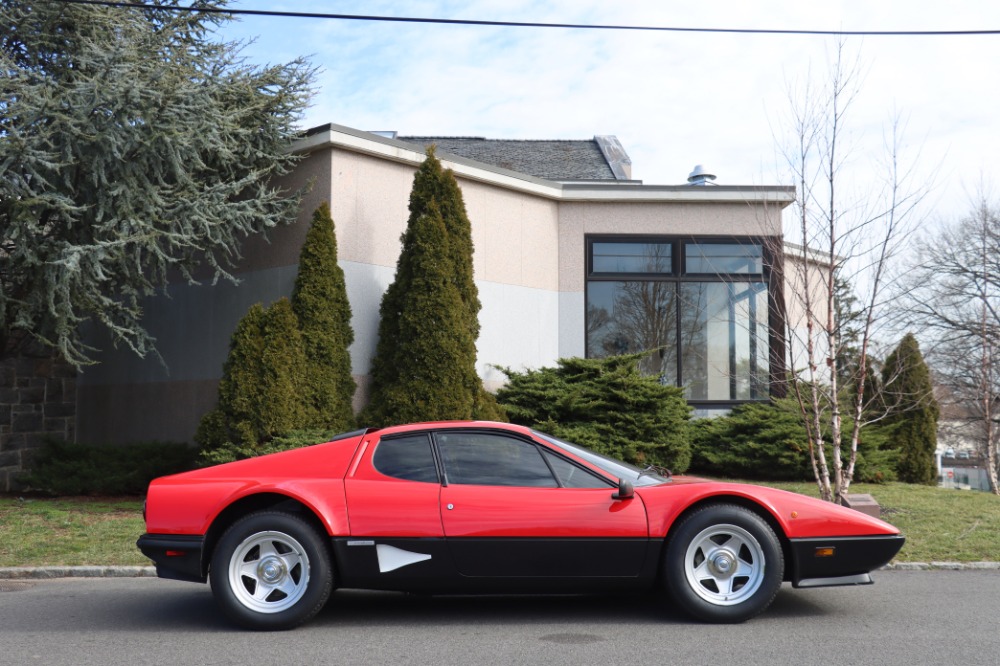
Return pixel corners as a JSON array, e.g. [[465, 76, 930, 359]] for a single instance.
[[684, 524, 765, 606]]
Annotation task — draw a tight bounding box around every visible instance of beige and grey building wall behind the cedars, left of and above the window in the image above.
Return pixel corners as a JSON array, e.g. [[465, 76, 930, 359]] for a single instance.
[[78, 128, 783, 442]]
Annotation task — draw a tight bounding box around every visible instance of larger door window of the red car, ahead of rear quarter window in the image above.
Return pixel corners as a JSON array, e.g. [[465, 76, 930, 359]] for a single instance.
[[435, 432, 558, 488]]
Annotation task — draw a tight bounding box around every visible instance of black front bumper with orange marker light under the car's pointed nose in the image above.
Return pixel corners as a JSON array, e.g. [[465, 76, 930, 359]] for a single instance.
[[790, 534, 906, 587]]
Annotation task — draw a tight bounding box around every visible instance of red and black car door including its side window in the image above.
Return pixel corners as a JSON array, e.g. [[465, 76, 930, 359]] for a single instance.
[[434, 430, 649, 577]]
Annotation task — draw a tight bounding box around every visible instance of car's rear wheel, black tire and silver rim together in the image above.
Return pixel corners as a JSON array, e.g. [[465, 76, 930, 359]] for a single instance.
[[209, 512, 333, 630]]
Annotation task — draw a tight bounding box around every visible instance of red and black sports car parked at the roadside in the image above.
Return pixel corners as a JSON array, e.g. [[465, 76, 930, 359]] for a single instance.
[[138, 422, 903, 629]]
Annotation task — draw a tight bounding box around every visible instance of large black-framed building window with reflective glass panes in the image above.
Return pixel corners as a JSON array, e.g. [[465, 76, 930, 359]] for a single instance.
[[587, 237, 772, 403]]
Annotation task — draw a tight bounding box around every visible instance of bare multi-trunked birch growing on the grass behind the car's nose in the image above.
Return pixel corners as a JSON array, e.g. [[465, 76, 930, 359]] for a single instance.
[[772, 42, 925, 502]]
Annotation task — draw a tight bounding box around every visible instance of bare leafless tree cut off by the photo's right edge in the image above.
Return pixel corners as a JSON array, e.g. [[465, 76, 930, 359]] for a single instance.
[[906, 189, 1000, 494]]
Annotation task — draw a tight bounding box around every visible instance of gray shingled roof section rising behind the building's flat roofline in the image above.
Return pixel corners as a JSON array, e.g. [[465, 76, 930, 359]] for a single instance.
[[396, 136, 627, 180]]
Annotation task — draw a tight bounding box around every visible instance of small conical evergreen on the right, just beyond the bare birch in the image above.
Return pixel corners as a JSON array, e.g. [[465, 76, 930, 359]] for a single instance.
[[882, 333, 940, 484]]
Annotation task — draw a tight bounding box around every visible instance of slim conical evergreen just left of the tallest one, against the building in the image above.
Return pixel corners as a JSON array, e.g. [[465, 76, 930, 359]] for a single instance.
[[292, 202, 356, 432]]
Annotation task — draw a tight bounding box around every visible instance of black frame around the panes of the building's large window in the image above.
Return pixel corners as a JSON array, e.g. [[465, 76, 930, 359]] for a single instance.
[[584, 234, 785, 410]]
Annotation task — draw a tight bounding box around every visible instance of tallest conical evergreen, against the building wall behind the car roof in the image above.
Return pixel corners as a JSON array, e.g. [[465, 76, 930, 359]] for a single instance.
[[359, 147, 504, 426]]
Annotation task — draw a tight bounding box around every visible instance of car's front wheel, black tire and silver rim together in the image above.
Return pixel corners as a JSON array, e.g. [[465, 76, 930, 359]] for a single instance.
[[664, 504, 785, 623]]
